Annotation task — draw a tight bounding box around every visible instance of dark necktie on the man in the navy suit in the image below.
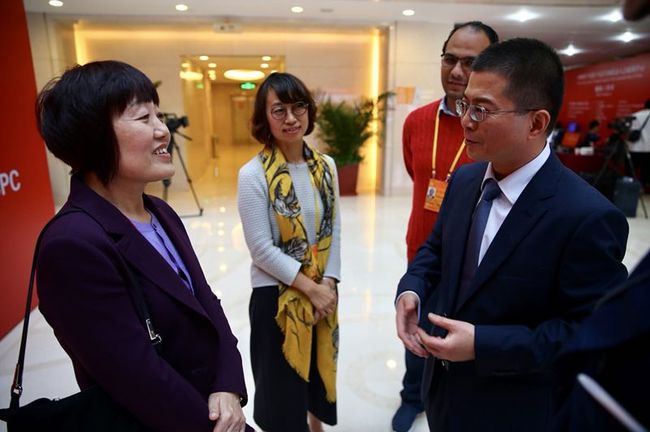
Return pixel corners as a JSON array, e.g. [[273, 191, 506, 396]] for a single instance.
[[456, 178, 501, 305]]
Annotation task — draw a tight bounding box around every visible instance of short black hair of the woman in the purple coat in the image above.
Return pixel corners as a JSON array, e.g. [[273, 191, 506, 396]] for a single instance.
[[36, 60, 159, 185]]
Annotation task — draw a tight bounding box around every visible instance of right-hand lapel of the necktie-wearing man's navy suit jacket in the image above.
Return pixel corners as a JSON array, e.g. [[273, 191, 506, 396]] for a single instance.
[[452, 154, 561, 311]]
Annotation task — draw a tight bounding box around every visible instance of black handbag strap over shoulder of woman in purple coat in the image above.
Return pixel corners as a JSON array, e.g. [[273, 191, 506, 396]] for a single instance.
[[9, 209, 162, 409]]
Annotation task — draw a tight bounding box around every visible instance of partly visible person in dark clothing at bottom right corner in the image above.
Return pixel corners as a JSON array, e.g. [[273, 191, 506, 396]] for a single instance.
[[554, 253, 650, 432]]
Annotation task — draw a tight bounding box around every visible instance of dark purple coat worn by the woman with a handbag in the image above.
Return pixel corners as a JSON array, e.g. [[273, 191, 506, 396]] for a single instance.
[[37, 177, 252, 432]]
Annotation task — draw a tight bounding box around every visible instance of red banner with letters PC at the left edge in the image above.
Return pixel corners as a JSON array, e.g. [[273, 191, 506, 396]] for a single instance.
[[0, 0, 54, 337]]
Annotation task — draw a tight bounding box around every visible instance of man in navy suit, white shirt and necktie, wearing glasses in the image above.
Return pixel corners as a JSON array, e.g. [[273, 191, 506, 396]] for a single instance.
[[396, 39, 628, 431]]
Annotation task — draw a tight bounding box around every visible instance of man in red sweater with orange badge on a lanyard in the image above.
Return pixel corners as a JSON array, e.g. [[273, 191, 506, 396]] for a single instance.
[[392, 21, 499, 432]]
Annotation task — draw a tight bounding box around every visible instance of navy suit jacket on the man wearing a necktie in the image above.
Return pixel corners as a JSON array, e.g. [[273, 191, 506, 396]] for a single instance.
[[398, 154, 628, 431]]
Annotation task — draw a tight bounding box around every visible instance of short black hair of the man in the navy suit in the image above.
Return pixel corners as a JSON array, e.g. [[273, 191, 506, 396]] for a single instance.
[[472, 38, 564, 134]]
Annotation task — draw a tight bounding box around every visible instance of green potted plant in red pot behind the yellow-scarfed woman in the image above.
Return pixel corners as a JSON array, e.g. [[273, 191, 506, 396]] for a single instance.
[[316, 92, 392, 195]]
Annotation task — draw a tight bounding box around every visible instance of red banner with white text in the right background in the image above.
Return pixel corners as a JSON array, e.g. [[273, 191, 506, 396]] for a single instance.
[[559, 53, 650, 137]]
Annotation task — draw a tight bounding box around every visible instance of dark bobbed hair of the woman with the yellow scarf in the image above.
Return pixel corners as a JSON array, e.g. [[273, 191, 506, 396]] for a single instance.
[[251, 72, 317, 145]]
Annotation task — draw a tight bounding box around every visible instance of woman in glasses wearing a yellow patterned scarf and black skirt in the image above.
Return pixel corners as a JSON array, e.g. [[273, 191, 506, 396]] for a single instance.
[[238, 73, 341, 432]]
